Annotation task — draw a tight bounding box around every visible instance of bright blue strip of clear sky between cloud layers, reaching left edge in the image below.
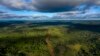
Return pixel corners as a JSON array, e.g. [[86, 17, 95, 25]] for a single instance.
[[0, 5, 54, 17]]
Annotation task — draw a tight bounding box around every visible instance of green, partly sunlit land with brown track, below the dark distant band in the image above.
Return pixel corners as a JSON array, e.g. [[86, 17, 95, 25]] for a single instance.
[[0, 25, 100, 56]]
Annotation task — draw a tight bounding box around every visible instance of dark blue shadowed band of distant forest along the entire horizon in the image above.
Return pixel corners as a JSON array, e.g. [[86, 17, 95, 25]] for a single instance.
[[0, 21, 100, 32]]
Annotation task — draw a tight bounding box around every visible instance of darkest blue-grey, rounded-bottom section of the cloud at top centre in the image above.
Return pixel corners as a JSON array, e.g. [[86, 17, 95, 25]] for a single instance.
[[34, 0, 86, 12]]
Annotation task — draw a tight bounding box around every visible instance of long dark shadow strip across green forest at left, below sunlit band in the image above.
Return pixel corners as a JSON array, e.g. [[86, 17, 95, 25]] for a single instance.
[[0, 36, 45, 45]]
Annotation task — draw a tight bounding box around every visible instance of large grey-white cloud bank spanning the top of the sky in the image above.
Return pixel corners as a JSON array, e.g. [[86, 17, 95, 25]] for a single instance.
[[0, 0, 100, 12]]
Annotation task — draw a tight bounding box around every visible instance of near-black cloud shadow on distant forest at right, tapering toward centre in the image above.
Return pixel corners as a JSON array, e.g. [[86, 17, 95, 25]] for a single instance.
[[29, 22, 100, 32]]
